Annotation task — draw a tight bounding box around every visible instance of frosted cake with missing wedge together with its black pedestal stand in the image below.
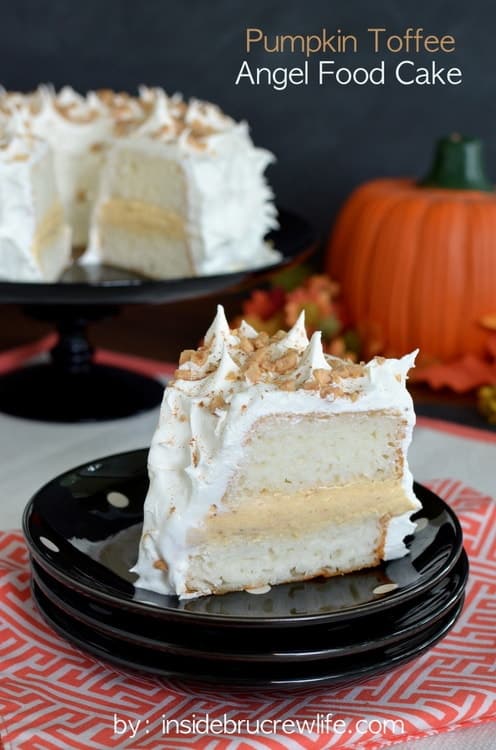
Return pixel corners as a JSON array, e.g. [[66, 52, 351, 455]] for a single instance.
[[0, 86, 314, 422]]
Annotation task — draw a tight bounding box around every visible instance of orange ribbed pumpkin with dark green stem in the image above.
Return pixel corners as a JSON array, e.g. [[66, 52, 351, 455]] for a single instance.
[[327, 136, 496, 368]]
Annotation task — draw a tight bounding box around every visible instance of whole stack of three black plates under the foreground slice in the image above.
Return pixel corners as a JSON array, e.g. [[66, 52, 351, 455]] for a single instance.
[[23, 450, 468, 688]]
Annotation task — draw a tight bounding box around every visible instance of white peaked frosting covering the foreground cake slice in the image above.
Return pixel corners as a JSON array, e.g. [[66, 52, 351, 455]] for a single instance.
[[133, 307, 420, 598]]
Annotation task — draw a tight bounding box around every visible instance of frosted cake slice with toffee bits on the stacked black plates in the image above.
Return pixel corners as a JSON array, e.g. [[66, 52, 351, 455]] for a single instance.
[[134, 308, 420, 598]]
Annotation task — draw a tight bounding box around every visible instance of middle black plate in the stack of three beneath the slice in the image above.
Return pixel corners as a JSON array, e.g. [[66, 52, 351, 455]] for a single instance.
[[31, 551, 468, 663]]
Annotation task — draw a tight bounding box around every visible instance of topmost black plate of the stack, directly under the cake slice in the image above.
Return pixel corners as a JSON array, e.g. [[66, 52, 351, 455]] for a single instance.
[[23, 450, 462, 628]]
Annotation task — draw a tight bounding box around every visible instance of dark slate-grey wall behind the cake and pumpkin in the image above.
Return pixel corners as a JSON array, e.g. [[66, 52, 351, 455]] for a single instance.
[[0, 0, 496, 235]]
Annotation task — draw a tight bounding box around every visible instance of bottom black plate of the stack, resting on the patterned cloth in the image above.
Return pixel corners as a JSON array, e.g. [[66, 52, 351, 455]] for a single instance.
[[33, 582, 463, 689]]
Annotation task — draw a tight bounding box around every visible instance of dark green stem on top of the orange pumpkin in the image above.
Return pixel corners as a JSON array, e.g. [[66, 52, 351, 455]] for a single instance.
[[418, 133, 494, 192]]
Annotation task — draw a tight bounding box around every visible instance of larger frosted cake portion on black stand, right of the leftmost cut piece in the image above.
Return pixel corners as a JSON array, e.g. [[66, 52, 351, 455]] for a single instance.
[[0, 86, 279, 278]]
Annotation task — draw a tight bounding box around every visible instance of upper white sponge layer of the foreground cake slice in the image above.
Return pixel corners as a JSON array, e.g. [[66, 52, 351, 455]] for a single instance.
[[225, 412, 406, 502]]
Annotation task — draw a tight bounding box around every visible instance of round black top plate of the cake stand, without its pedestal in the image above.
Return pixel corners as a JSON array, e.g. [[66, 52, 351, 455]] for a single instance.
[[0, 209, 316, 305]]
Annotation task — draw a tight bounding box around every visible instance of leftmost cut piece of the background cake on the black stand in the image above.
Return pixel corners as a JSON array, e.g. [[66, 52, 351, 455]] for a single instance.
[[0, 130, 71, 281]]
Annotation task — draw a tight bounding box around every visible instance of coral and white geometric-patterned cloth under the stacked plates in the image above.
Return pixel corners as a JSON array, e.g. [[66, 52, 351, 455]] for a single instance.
[[0, 480, 496, 750]]
